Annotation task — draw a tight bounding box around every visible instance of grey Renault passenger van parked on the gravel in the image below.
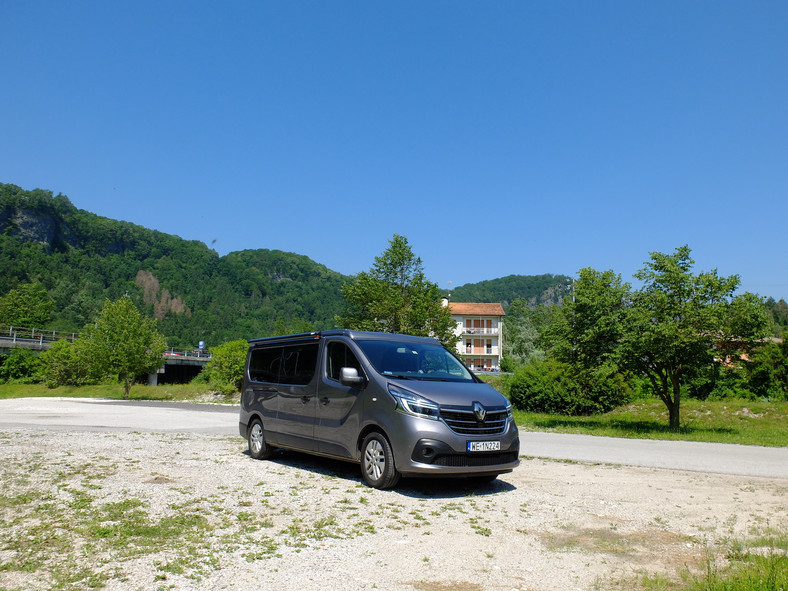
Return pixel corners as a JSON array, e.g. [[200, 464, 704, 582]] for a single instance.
[[238, 330, 520, 489]]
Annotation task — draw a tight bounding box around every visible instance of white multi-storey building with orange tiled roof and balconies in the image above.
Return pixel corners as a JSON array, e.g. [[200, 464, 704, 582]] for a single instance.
[[446, 302, 504, 371]]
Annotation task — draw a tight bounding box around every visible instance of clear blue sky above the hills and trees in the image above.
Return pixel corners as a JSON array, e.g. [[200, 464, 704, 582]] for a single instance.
[[0, 0, 788, 299]]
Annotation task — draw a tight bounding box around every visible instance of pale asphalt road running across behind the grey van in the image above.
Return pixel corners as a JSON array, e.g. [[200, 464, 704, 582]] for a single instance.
[[0, 398, 788, 479]]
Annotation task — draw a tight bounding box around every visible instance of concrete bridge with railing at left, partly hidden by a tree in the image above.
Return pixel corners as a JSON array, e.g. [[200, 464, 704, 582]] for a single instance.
[[0, 326, 211, 385]]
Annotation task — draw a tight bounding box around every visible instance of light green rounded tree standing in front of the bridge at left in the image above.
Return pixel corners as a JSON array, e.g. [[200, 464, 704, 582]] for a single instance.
[[75, 296, 167, 400]]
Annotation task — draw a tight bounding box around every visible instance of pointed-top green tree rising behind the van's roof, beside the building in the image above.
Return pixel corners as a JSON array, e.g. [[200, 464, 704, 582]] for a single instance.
[[336, 234, 459, 348]]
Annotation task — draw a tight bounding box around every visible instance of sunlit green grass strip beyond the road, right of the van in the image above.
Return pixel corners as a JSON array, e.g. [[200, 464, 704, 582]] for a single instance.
[[514, 399, 788, 447]]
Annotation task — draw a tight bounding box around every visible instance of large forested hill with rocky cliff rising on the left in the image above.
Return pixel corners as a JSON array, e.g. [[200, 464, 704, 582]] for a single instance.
[[0, 183, 349, 347]]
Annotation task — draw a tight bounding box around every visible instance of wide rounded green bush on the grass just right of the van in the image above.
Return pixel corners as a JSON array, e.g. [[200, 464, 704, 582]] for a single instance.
[[509, 360, 633, 416]]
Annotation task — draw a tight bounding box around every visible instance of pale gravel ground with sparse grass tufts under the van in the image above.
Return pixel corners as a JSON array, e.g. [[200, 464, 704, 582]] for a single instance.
[[0, 430, 788, 591]]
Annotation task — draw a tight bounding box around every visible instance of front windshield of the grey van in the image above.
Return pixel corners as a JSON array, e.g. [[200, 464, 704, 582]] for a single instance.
[[357, 340, 475, 382]]
